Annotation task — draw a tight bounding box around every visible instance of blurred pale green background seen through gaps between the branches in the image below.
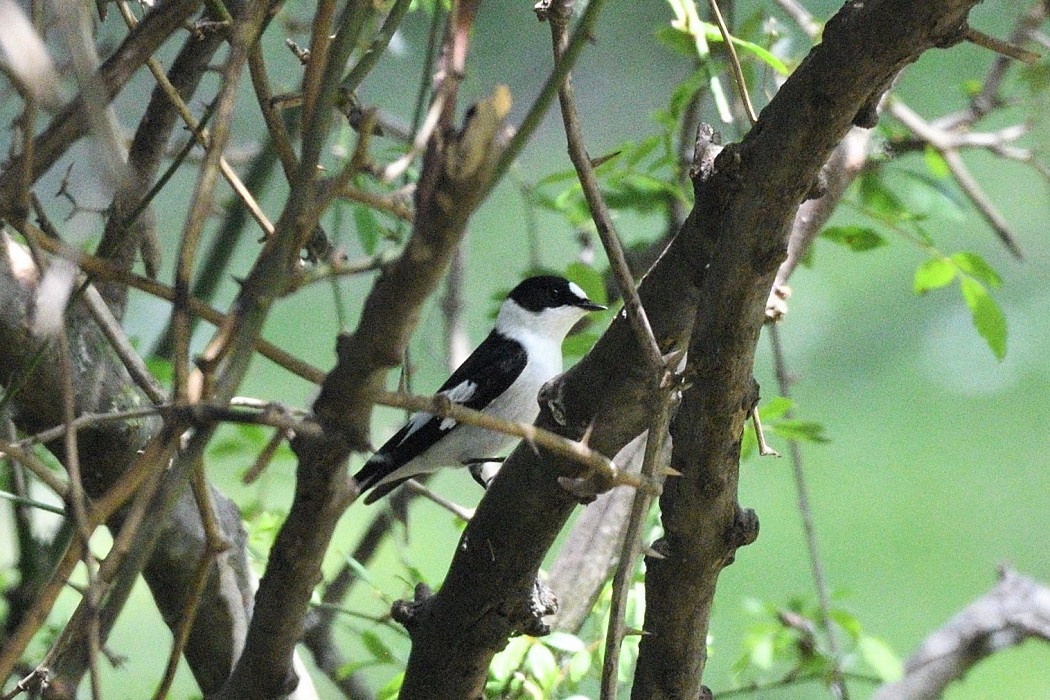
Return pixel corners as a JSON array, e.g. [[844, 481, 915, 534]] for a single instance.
[[0, 0, 1050, 700]]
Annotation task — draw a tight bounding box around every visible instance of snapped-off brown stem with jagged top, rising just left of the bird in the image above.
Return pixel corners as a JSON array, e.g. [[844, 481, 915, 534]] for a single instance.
[[218, 25, 510, 699]]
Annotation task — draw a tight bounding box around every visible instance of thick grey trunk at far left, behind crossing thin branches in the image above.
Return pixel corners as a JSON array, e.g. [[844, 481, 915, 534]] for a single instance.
[[0, 240, 251, 692]]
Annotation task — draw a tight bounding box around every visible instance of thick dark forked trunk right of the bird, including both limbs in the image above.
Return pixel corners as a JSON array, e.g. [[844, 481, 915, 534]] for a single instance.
[[399, 0, 974, 698]]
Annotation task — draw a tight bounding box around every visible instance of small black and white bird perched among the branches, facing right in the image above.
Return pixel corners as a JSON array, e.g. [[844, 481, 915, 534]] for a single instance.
[[354, 276, 605, 503]]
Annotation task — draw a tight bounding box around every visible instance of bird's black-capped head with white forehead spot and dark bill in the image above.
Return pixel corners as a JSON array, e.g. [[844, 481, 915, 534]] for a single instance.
[[496, 275, 605, 341]]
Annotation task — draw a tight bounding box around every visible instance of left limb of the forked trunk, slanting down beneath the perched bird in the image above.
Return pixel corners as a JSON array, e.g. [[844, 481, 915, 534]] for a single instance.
[[401, 139, 709, 698]]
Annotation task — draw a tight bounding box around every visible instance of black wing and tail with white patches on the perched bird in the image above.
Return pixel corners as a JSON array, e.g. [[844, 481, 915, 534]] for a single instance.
[[354, 331, 528, 503]]
